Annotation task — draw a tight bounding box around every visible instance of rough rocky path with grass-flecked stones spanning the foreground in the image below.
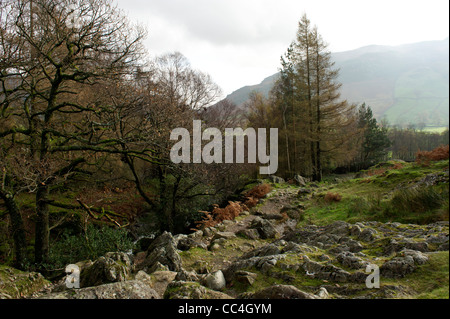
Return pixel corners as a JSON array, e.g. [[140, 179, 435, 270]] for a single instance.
[[0, 182, 449, 299]]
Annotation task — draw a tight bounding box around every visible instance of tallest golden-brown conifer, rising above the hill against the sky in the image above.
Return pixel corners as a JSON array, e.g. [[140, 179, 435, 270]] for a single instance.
[[277, 15, 353, 181]]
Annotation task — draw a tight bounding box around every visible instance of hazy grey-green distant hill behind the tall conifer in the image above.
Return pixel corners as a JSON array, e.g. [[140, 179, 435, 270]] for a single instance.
[[223, 38, 449, 126]]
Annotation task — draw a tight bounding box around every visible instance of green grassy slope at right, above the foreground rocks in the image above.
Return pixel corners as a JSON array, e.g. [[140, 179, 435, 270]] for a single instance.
[[299, 160, 449, 225]]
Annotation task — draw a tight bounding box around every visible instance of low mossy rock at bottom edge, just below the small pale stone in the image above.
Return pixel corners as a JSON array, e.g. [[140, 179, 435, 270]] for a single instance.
[[164, 281, 233, 299]]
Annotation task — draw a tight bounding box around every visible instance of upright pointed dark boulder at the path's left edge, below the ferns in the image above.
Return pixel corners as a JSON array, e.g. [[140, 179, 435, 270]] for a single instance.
[[136, 232, 185, 273]]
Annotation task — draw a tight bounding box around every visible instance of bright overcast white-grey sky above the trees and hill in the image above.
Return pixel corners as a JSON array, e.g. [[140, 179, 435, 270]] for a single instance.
[[116, 0, 449, 96]]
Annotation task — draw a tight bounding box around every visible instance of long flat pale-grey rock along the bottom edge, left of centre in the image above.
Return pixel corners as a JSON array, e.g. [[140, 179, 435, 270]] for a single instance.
[[39, 280, 160, 299]]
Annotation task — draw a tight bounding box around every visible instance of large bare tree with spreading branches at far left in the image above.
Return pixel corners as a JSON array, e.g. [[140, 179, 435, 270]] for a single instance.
[[0, 0, 145, 263]]
